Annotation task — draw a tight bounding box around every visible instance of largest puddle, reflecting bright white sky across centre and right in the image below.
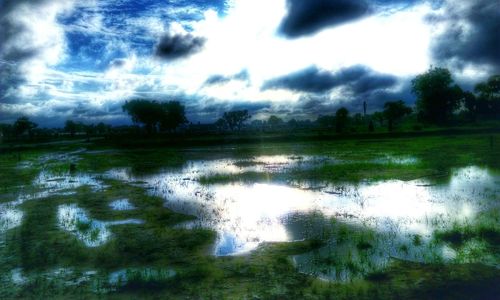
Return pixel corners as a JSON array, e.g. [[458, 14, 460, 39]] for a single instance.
[[103, 156, 500, 280]]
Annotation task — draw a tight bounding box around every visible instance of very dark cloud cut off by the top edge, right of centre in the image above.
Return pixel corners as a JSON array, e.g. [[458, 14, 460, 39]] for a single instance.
[[279, 0, 369, 37]]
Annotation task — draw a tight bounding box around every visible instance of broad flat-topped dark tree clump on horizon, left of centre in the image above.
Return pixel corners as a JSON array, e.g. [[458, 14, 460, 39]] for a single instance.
[[122, 100, 187, 133]]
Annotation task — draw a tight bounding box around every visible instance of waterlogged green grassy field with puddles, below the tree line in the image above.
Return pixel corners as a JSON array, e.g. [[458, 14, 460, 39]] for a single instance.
[[0, 136, 500, 299]]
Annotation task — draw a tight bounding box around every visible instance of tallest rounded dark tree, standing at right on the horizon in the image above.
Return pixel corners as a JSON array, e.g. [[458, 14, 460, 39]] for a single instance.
[[412, 68, 462, 124]]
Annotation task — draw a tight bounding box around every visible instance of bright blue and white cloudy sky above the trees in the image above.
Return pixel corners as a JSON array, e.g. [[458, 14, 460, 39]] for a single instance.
[[0, 0, 500, 127]]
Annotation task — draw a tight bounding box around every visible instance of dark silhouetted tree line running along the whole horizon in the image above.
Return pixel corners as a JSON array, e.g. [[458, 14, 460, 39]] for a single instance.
[[0, 67, 500, 138]]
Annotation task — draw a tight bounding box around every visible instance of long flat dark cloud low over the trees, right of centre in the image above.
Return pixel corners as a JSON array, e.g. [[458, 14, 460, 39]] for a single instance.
[[262, 66, 397, 94]]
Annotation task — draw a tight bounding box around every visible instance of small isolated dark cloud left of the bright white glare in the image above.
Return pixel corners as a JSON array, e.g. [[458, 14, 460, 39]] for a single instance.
[[155, 33, 206, 60]]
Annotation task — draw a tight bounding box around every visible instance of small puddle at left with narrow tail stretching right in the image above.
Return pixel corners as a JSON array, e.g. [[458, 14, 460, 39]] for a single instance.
[[57, 204, 143, 247]]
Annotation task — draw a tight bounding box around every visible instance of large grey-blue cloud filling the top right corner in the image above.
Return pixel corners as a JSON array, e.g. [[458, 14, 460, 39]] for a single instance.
[[429, 0, 500, 72]]
